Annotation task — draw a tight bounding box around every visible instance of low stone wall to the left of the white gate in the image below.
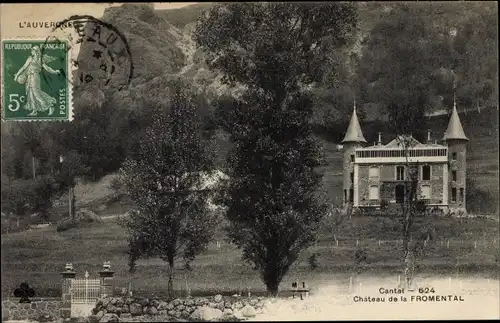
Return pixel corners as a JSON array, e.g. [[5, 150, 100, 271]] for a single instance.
[[2, 299, 62, 322]]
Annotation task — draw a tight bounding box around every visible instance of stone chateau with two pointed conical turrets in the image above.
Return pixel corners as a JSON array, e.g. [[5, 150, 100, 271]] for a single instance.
[[342, 100, 468, 211]]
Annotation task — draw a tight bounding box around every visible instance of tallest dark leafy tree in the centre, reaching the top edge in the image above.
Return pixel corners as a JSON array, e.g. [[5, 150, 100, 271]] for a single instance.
[[194, 3, 356, 295]]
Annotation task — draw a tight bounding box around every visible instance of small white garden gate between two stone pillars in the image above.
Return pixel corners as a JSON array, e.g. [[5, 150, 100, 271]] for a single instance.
[[70, 271, 101, 317]]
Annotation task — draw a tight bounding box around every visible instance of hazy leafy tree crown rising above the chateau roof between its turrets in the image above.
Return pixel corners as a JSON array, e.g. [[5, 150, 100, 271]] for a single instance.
[[358, 3, 452, 138]]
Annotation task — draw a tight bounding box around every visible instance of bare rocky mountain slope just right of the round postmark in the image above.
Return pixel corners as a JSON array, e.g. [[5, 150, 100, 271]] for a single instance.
[[75, 4, 229, 112]]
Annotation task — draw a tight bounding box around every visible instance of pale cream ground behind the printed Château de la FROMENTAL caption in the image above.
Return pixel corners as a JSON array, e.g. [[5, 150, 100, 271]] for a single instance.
[[253, 278, 500, 321]]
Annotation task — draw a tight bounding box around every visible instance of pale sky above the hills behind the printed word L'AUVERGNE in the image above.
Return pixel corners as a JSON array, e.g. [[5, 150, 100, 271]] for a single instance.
[[0, 2, 196, 38]]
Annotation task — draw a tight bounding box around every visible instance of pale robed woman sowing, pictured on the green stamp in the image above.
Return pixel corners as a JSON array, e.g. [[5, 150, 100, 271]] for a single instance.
[[14, 46, 60, 116]]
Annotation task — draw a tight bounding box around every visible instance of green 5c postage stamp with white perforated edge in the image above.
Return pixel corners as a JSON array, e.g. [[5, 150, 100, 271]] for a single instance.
[[1, 39, 72, 121]]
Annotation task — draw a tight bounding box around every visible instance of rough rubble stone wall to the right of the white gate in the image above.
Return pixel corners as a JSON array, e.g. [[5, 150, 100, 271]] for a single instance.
[[89, 295, 265, 323]]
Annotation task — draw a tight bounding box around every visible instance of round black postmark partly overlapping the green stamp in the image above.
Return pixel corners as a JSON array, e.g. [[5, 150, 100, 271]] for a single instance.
[[42, 15, 134, 91]]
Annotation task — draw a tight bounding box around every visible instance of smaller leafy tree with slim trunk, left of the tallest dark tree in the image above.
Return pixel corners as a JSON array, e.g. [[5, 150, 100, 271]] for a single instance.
[[121, 83, 217, 296]]
